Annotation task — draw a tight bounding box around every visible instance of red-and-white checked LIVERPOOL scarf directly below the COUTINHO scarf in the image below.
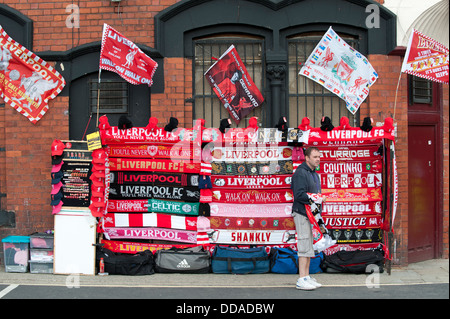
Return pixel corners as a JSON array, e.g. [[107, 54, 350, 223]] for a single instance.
[[320, 173, 383, 188]]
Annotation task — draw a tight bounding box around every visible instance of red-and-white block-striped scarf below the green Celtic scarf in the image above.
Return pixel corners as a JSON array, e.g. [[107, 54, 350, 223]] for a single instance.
[[103, 213, 210, 231]]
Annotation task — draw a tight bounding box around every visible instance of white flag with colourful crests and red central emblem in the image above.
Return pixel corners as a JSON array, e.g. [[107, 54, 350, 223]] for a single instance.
[[299, 27, 378, 114]]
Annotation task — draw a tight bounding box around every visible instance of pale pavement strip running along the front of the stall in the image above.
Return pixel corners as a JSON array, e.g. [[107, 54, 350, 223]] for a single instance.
[[0, 259, 449, 288]]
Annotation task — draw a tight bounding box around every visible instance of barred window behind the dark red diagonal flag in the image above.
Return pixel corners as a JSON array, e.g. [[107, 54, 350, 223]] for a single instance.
[[193, 35, 264, 127]]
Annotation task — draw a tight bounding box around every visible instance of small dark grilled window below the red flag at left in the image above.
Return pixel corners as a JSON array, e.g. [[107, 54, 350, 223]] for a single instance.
[[89, 79, 129, 113]]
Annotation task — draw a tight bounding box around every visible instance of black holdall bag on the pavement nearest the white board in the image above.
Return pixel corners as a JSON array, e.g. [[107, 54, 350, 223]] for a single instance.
[[96, 248, 155, 276]]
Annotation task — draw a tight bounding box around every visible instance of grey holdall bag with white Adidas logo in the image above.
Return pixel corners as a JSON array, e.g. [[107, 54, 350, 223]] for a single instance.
[[155, 246, 211, 274]]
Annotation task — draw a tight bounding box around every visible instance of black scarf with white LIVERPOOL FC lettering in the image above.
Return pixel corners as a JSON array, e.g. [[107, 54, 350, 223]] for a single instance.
[[109, 184, 200, 202]]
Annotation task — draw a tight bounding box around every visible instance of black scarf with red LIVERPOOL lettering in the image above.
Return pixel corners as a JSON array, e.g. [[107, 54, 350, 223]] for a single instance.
[[110, 171, 199, 186]]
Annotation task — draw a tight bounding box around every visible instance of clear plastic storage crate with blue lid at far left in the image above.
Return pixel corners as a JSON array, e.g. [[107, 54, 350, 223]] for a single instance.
[[2, 236, 30, 272]]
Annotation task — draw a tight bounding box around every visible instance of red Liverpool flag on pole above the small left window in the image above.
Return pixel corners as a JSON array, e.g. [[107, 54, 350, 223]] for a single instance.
[[100, 23, 158, 86]]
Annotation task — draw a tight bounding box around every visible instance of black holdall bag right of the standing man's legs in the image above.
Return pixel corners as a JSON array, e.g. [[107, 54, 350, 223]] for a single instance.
[[320, 248, 385, 274]]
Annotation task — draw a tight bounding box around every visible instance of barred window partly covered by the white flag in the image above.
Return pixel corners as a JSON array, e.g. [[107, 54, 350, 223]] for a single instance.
[[288, 33, 359, 127]]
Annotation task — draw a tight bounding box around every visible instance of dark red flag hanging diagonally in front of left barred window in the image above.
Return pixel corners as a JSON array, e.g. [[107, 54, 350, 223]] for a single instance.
[[205, 45, 264, 124]]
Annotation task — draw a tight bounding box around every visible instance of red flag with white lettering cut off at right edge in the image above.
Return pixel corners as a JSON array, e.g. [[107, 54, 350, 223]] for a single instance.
[[402, 29, 449, 84]]
